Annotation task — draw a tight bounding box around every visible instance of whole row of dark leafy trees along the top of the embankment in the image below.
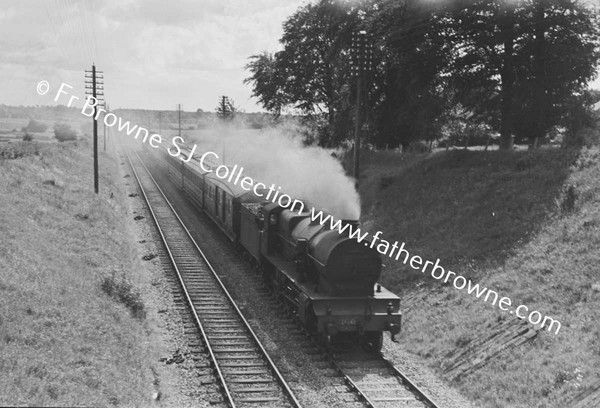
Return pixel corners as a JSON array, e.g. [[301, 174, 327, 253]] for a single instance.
[[245, 0, 600, 148]]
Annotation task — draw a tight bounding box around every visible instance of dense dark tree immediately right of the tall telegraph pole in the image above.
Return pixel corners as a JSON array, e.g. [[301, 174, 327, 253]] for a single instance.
[[368, 0, 448, 148]]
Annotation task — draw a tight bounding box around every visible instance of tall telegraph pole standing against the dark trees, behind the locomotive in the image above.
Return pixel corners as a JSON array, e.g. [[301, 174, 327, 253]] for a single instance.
[[350, 30, 373, 189]]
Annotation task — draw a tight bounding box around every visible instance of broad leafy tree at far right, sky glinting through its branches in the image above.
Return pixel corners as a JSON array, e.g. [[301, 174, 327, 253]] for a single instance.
[[439, 0, 599, 149]]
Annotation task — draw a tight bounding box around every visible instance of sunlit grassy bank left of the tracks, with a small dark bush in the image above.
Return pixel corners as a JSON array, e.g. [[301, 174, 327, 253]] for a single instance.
[[0, 141, 156, 406]]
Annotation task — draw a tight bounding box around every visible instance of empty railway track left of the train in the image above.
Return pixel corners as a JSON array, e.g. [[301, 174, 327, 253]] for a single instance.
[[127, 154, 301, 408]]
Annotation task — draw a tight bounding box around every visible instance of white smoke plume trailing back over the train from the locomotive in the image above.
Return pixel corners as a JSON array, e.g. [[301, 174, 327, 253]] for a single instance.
[[184, 124, 360, 220]]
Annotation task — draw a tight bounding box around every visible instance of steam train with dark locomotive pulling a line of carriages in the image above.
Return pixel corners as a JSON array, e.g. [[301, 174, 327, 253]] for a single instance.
[[163, 148, 402, 351]]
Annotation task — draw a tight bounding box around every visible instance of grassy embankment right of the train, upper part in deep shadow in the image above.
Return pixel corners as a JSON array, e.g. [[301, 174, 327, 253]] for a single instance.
[[361, 148, 600, 408]]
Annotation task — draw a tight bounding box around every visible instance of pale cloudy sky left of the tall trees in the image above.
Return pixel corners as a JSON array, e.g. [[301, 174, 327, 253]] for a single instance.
[[0, 0, 600, 112]]
